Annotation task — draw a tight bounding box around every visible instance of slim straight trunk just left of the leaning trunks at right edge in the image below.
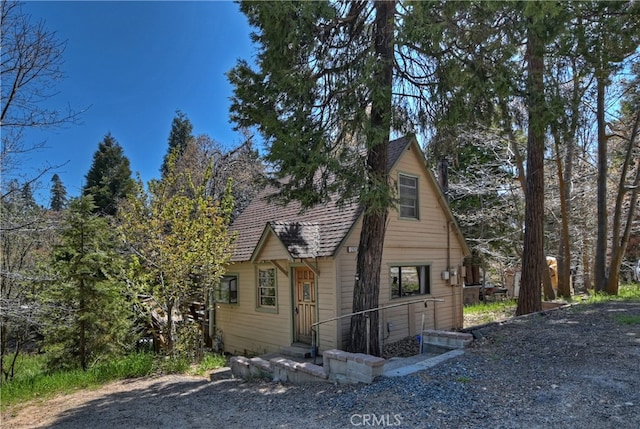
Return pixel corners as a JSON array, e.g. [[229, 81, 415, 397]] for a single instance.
[[594, 75, 607, 292]]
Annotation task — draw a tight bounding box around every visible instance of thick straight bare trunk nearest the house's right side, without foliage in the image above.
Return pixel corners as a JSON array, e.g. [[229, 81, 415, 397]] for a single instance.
[[516, 17, 547, 315]]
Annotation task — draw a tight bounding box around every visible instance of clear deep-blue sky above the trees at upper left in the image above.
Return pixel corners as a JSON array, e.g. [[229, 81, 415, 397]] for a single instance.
[[22, 1, 255, 205]]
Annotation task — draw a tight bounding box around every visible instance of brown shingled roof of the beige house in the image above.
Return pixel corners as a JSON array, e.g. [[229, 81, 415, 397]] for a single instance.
[[231, 137, 412, 262]]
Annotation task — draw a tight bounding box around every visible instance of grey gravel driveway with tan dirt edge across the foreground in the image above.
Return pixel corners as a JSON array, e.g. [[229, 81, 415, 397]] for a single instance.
[[1, 303, 640, 429]]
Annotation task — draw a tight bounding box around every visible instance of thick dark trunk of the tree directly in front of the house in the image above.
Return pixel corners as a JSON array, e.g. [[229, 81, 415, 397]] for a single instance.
[[349, 1, 395, 356]]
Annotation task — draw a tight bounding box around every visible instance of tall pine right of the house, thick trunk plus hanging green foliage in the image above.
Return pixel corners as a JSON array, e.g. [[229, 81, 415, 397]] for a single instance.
[[405, 2, 564, 314]]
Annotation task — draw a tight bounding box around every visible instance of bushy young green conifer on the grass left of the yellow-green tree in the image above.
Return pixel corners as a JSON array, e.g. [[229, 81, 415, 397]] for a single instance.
[[42, 195, 132, 370]]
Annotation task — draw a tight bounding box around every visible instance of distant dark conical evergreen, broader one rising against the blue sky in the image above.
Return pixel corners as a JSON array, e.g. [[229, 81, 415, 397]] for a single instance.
[[82, 133, 135, 216]]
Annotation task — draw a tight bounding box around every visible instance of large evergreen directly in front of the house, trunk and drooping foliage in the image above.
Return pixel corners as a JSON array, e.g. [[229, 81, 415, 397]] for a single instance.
[[228, 1, 398, 354]]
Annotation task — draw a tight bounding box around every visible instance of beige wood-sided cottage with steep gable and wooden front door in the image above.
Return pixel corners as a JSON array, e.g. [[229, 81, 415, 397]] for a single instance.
[[214, 137, 469, 354]]
